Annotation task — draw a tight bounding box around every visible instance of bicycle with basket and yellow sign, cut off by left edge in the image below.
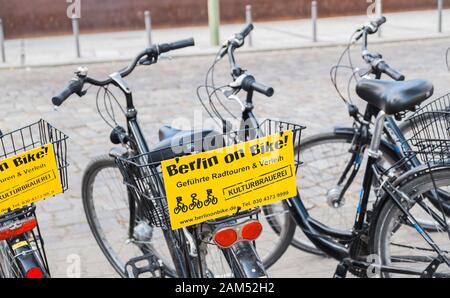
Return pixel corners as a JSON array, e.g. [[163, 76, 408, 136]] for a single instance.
[[0, 120, 68, 278]]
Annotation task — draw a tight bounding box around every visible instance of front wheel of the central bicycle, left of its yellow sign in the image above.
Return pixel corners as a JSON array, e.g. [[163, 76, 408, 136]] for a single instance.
[[82, 155, 177, 277]]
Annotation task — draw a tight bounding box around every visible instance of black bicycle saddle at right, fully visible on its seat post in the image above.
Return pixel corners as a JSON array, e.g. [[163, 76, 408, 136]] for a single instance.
[[356, 80, 434, 115]]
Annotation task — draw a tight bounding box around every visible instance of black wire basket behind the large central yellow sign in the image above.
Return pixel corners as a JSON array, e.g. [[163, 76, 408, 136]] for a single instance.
[[116, 120, 305, 228]]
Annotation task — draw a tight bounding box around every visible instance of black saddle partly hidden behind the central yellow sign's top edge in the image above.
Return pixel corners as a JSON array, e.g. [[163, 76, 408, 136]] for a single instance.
[[150, 126, 224, 162]]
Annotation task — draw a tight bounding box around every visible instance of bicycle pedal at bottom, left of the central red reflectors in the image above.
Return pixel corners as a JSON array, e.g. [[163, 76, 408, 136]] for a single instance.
[[125, 253, 165, 278]]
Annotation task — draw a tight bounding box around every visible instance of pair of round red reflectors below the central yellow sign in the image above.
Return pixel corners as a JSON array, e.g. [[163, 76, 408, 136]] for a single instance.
[[213, 220, 263, 248]]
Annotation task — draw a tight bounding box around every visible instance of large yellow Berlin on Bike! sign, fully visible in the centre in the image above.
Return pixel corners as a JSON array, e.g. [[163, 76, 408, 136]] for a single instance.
[[162, 131, 297, 229]]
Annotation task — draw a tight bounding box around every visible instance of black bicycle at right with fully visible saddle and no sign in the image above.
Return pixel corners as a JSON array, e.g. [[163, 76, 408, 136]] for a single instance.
[[270, 18, 449, 277]]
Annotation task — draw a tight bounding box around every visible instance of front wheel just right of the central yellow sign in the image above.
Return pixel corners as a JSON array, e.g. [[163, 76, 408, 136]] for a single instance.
[[292, 132, 396, 254]]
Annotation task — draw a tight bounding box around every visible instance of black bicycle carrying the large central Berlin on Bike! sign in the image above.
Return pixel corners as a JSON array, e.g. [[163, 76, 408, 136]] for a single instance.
[[53, 39, 299, 277]]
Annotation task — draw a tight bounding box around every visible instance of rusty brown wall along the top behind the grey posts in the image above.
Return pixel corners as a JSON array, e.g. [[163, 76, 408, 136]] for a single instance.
[[0, 0, 450, 38]]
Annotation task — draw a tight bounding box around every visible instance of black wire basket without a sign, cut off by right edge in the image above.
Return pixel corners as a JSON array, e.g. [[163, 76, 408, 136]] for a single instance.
[[403, 94, 450, 163]]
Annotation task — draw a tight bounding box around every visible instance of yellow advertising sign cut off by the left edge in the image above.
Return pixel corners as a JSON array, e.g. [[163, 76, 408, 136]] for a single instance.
[[0, 144, 62, 214]]
